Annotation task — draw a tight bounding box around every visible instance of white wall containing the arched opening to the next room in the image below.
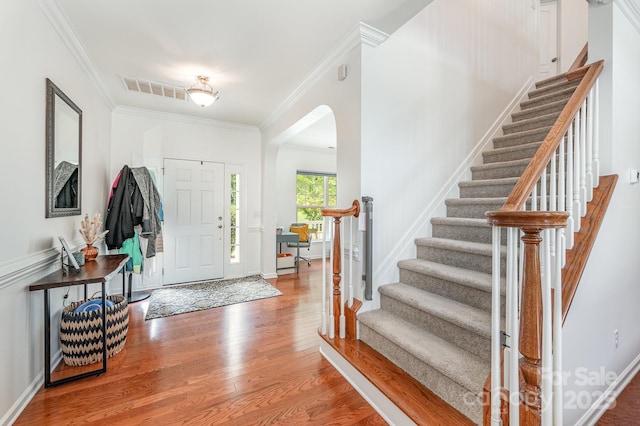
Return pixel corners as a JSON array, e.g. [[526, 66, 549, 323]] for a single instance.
[[261, 28, 368, 277]]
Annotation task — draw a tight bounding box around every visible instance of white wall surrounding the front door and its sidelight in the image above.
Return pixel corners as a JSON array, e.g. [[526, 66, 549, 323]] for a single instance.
[[110, 107, 262, 282]]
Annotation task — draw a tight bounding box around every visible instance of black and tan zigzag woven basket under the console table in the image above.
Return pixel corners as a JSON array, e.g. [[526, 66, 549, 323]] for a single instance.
[[60, 295, 129, 365]]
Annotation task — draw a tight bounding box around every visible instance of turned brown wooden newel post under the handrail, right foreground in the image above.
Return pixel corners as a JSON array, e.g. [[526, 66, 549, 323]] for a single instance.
[[519, 227, 542, 425]]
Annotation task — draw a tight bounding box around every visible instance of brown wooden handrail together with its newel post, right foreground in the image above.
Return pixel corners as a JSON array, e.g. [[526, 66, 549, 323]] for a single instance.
[[485, 60, 603, 425]]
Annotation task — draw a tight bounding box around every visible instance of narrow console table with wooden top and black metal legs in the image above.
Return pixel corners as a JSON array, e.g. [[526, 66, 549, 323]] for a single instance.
[[29, 254, 129, 388]]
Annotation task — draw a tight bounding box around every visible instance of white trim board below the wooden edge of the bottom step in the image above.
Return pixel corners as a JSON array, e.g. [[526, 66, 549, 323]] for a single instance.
[[320, 339, 415, 426]]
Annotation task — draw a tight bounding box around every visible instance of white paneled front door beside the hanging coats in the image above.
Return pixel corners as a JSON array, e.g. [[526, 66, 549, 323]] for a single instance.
[[163, 159, 224, 284]]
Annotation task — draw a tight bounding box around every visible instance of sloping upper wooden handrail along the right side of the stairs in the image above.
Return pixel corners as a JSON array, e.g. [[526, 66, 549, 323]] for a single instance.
[[500, 61, 603, 211]]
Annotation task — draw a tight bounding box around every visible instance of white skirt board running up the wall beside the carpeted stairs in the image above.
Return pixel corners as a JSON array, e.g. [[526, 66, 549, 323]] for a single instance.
[[358, 75, 535, 316]]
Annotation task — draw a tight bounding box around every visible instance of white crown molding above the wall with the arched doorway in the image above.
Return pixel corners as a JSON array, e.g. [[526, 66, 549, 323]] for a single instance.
[[258, 22, 389, 131]]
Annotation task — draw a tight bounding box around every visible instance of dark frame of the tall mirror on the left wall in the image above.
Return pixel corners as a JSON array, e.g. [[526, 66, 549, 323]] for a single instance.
[[45, 78, 82, 217]]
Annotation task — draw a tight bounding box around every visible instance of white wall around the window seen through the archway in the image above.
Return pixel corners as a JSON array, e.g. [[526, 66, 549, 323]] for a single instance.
[[275, 145, 336, 259]]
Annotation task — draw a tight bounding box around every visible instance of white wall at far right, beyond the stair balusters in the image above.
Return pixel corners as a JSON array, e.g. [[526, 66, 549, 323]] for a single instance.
[[564, 1, 640, 424]]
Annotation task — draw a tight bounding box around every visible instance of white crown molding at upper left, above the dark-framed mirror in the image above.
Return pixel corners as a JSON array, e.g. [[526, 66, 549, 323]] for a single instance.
[[38, 0, 115, 110]]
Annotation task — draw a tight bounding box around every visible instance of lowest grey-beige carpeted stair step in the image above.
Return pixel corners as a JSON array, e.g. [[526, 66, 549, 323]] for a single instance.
[[358, 310, 490, 392]]
